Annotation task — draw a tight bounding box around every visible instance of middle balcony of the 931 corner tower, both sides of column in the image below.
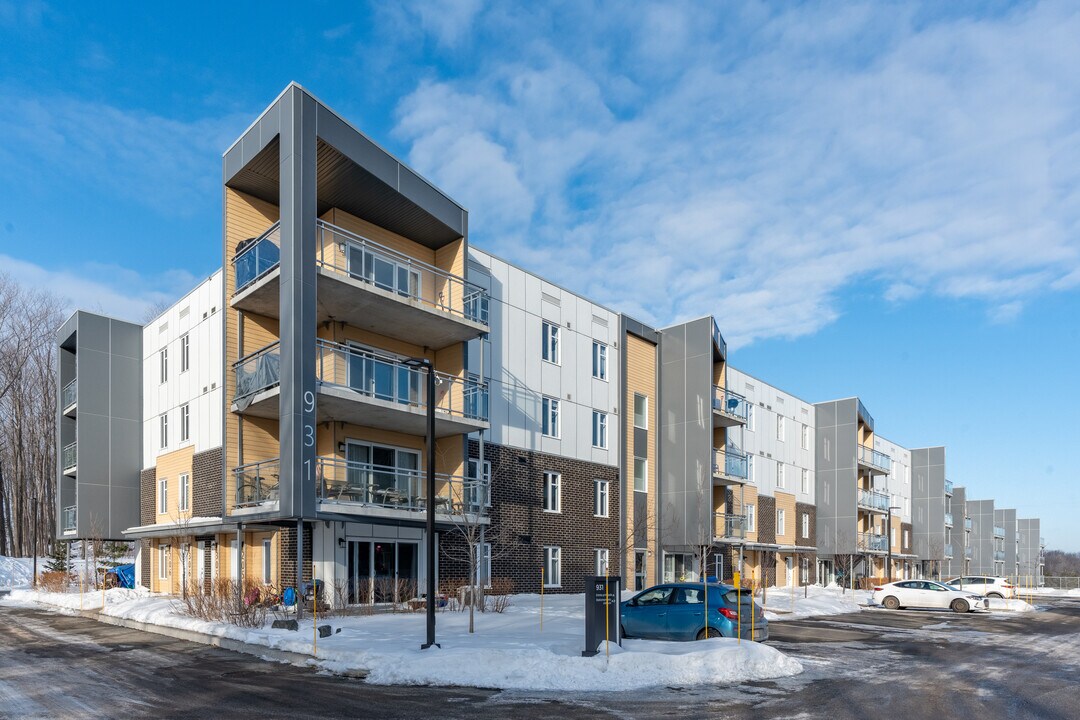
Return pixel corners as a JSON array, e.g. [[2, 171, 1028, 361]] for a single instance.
[[232, 340, 488, 437]]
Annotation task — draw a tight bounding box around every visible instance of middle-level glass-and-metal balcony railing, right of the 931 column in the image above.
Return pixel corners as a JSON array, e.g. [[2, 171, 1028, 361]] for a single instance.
[[315, 340, 488, 420]]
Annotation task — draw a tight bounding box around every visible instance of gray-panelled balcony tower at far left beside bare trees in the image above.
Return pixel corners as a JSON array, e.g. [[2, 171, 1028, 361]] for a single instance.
[[56, 311, 143, 540]]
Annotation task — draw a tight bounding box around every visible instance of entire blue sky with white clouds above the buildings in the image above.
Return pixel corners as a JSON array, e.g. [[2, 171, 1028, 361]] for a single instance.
[[0, 0, 1080, 549]]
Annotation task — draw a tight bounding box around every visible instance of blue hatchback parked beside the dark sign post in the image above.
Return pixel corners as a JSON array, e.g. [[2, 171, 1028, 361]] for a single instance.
[[622, 583, 769, 642]]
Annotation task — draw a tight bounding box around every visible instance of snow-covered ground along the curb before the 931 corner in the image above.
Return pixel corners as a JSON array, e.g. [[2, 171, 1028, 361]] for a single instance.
[[0, 588, 802, 691]]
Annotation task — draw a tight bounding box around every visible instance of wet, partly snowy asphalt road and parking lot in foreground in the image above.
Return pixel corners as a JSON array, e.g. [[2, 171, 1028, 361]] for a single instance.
[[0, 599, 1080, 720]]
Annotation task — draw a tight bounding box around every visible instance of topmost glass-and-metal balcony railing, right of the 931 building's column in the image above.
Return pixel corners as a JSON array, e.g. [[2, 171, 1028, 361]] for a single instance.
[[316, 220, 489, 325]]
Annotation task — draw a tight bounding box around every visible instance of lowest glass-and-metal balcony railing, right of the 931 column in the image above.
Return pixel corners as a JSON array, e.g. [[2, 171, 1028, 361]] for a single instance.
[[315, 457, 491, 515]]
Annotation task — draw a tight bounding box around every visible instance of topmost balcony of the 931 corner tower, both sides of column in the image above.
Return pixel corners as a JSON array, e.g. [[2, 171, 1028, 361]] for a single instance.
[[231, 220, 489, 350]]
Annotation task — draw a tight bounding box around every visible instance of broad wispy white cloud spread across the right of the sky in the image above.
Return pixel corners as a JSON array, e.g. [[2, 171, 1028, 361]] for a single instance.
[[388, 3, 1080, 344]]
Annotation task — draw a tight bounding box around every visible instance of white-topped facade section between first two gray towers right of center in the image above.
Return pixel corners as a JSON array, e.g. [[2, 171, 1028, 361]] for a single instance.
[[717, 367, 818, 585]]
